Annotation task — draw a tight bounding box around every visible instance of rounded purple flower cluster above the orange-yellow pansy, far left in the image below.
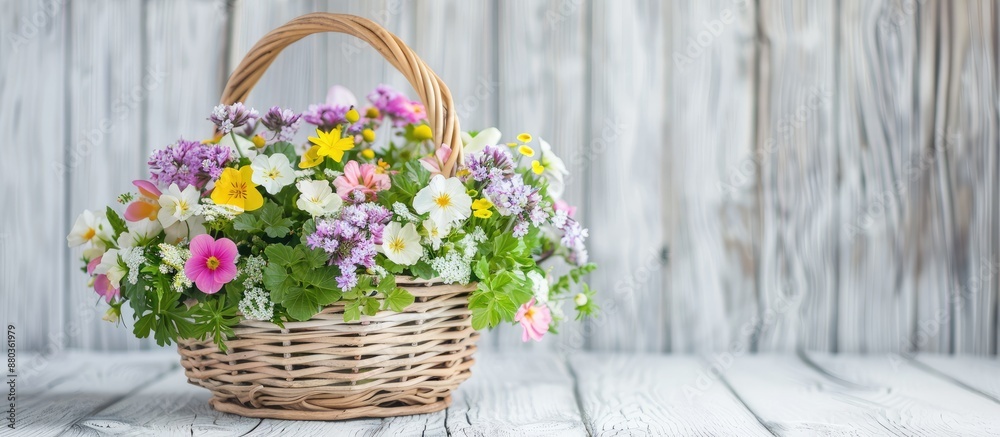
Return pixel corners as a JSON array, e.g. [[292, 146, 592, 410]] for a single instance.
[[147, 139, 232, 190]]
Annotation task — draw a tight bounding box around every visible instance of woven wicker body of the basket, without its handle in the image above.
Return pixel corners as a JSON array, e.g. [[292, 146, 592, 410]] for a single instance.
[[177, 276, 479, 420]]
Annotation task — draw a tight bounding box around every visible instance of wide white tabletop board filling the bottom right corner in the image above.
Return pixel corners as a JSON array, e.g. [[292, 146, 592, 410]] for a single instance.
[[722, 355, 1000, 435]]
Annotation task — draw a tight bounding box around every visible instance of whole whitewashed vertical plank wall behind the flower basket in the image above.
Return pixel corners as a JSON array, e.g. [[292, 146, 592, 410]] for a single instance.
[[0, 0, 1000, 355]]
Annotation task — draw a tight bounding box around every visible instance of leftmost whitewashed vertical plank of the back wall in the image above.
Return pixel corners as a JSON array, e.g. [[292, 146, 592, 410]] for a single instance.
[[0, 1, 69, 350]]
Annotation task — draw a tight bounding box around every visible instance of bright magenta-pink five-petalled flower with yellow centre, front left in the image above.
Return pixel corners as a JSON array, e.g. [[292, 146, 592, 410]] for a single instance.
[[184, 234, 239, 294]]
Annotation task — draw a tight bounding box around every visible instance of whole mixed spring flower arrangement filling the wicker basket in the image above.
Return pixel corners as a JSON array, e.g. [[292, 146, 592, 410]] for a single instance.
[[67, 86, 597, 350]]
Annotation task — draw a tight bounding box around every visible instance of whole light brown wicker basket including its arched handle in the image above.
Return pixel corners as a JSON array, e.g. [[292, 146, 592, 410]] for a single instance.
[[177, 13, 478, 420]]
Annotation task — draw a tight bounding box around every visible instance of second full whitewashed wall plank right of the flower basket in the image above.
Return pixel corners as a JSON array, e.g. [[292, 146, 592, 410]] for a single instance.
[[668, 1, 761, 352]]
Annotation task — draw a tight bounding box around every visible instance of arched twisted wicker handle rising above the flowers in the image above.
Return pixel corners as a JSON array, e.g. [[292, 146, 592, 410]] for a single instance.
[[222, 12, 462, 175]]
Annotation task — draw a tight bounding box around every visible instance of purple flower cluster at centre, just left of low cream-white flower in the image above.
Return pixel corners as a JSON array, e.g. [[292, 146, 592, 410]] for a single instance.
[[306, 203, 392, 290]]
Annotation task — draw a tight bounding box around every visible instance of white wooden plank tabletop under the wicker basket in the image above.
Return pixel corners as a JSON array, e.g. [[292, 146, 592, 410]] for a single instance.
[[7, 350, 1000, 436]]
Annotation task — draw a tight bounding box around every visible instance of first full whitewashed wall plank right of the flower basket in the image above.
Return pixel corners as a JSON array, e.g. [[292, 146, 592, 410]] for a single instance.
[[577, 1, 667, 351]]
